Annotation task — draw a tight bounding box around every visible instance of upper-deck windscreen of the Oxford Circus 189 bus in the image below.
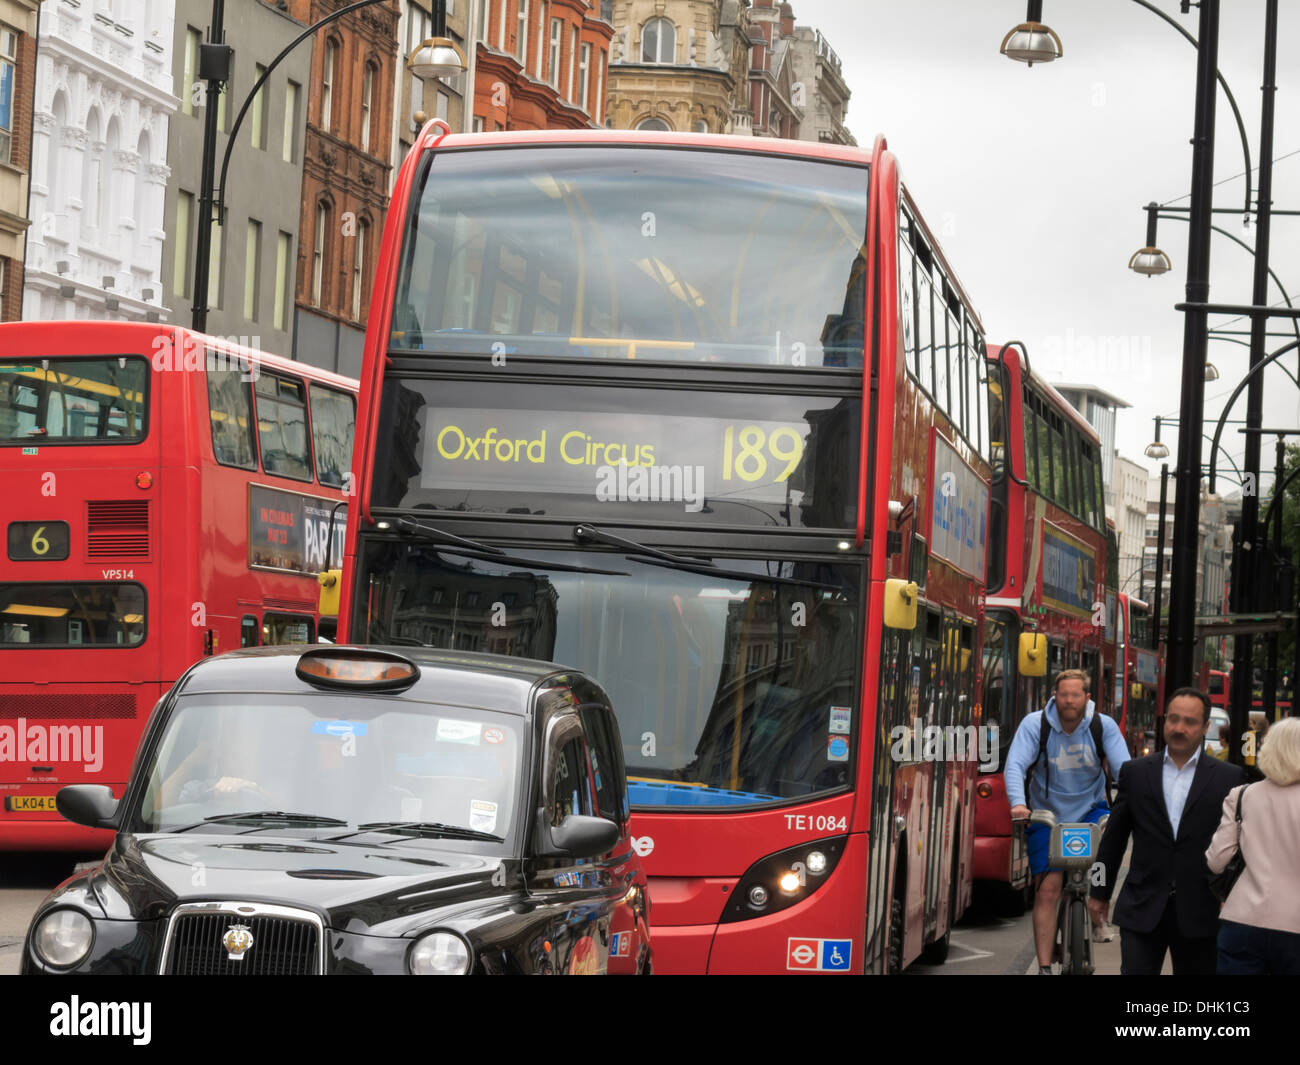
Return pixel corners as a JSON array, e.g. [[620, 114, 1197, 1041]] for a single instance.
[[391, 147, 867, 368]]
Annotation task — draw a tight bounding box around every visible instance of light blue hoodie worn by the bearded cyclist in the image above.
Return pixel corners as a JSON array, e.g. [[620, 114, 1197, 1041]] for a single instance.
[[1006, 696, 1128, 822]]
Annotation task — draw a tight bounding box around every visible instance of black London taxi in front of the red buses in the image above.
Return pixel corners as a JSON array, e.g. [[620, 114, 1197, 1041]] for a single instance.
[[30, 646, 651, 975]]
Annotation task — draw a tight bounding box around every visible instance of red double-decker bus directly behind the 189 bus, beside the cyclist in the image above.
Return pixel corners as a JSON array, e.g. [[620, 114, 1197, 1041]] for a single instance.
[[974, 345, 1113, 897]]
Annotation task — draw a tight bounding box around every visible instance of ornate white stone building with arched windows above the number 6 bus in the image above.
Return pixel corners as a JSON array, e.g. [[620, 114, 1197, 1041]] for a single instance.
[[23, 0, 179, 321]]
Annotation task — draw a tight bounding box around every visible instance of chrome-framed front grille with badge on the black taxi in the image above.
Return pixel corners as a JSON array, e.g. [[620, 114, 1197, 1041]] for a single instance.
[[163, 913, 320, 977]]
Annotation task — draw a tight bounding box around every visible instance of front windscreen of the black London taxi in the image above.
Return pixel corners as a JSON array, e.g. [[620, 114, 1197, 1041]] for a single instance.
[[137, 694, 520, 839]]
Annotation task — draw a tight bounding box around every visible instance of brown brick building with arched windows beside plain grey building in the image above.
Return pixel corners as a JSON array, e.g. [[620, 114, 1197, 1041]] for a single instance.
[[289, 0, 402, 377]]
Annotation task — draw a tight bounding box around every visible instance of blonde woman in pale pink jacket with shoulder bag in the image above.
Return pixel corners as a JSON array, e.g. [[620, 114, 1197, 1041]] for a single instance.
[[1205, 718, 1300, 975]]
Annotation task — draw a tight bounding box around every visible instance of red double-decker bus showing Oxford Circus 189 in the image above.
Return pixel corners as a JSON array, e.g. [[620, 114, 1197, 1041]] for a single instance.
[[339, 122, 989, 973]]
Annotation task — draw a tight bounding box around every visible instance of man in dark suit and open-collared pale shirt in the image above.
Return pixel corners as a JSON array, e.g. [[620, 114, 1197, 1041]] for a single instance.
[[1088, 688, 1244, 975]]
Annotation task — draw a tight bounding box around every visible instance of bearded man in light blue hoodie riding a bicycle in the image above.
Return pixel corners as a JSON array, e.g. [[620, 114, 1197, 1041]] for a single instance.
[[1005, 670, 1128, 975]]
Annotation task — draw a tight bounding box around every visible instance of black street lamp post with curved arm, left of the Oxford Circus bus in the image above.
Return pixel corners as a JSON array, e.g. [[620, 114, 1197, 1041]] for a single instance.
[[191, 0, 462, 333]]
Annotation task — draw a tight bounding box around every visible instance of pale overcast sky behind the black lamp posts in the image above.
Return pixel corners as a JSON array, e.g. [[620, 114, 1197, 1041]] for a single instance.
[[793, 0, 1300, 492]]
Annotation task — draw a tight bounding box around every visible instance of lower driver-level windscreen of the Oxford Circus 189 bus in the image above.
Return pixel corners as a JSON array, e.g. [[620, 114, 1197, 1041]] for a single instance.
[[356, 540, 862, 810]]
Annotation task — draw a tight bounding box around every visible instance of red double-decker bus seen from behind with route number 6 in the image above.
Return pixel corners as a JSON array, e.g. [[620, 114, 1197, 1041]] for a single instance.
[[0, 321, 356, 850]]
